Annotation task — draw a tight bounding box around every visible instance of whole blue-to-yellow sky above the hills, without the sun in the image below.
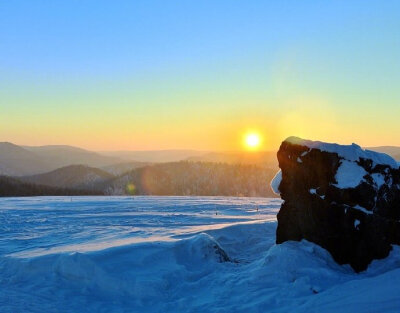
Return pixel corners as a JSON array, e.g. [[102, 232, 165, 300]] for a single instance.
[[0, 0, 400, 150]]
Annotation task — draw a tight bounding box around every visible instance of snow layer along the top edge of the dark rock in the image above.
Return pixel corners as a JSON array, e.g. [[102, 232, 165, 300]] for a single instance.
[[285, 136, 399, 169]]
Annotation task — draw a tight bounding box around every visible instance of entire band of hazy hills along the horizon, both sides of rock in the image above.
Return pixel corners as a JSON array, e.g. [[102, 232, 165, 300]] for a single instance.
[[0, 142, 400, 196]]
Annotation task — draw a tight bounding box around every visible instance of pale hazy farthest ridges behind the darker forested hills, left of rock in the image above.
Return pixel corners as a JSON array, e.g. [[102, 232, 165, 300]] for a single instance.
[[0, 142, 277, 176]]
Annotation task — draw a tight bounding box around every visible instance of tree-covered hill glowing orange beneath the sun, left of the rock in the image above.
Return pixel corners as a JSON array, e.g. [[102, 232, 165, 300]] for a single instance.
[[105, 161, 277, 197]]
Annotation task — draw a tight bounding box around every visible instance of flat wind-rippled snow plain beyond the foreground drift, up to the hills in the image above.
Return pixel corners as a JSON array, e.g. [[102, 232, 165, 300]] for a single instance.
[[0, 197, 281, 257]]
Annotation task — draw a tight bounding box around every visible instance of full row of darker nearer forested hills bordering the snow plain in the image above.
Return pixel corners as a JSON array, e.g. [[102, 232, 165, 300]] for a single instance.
[[0, 161, 277, 197]]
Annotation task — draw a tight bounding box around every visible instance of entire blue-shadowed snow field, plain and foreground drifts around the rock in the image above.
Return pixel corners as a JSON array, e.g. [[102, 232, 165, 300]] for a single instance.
[[0, 197, 400, 313]]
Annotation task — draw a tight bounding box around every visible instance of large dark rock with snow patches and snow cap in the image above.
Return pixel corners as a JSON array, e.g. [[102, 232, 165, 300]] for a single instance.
[[271, 137, 400, 271]]
